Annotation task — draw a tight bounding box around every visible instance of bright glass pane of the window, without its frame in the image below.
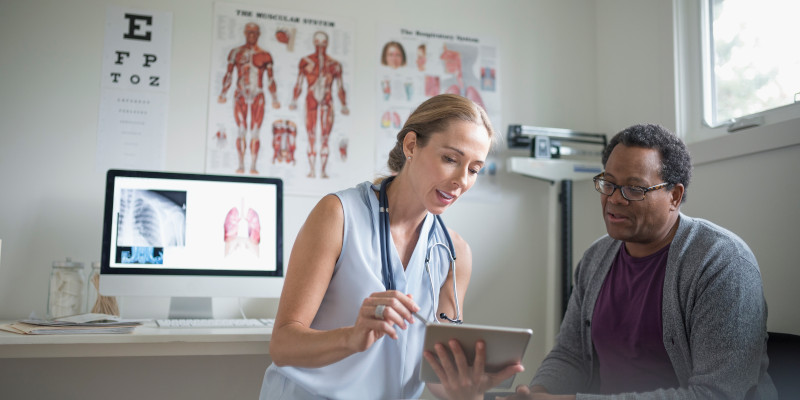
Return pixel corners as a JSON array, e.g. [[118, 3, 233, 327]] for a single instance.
[[702, 0, 800, 127]]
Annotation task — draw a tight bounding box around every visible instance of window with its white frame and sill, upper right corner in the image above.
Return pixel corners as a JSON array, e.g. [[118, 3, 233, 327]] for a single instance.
[[673, 0, 800, 144]]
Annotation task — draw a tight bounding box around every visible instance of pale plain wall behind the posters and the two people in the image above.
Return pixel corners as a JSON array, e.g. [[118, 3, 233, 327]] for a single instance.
[[0, 0, 800, 393]]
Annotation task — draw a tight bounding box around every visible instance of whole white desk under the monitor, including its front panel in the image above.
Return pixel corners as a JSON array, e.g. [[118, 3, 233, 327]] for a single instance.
[[0, 322, 272, 400]]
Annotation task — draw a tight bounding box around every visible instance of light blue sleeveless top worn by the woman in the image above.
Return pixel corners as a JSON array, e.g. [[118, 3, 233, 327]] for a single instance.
[[260, 182, 450, 400]]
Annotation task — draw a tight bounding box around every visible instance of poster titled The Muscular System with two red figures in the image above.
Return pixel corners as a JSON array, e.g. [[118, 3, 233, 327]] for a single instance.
[[206, 3, 354, 194]]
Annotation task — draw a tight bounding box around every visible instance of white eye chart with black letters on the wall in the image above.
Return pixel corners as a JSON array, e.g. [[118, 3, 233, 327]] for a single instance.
[[95, 6, 172, 171]]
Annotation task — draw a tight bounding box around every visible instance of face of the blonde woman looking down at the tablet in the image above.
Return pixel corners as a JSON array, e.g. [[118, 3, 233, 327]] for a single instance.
[[407, 120, 491, 214]]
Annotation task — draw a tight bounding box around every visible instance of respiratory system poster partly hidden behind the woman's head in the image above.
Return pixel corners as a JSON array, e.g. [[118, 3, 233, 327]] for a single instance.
[[375, 27, 505, 199]]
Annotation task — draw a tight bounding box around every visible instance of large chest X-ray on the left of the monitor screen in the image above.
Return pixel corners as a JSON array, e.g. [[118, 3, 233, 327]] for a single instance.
[[117, 189, 186, 248]]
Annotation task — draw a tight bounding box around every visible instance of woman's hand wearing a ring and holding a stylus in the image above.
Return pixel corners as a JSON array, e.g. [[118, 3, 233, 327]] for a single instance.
[[348, 290, 419, 352]]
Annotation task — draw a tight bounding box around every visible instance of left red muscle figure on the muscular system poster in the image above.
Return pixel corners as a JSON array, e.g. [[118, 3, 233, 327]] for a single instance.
[[217, 22, 281, 174]]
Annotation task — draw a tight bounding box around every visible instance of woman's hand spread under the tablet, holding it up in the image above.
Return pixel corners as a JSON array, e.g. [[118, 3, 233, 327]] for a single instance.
[[423, 339, 525, 400]]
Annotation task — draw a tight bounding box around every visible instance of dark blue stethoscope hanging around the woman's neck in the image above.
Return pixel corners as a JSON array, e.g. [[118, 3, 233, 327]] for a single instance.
[[378, 176, 463, 324]]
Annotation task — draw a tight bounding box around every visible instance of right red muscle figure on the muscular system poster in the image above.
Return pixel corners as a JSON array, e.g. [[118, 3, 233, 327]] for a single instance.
[[289, 31, 350, 178]]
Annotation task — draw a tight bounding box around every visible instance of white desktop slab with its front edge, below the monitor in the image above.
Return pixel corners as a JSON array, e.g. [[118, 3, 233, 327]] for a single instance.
[[0, 322, 272, 358]]
